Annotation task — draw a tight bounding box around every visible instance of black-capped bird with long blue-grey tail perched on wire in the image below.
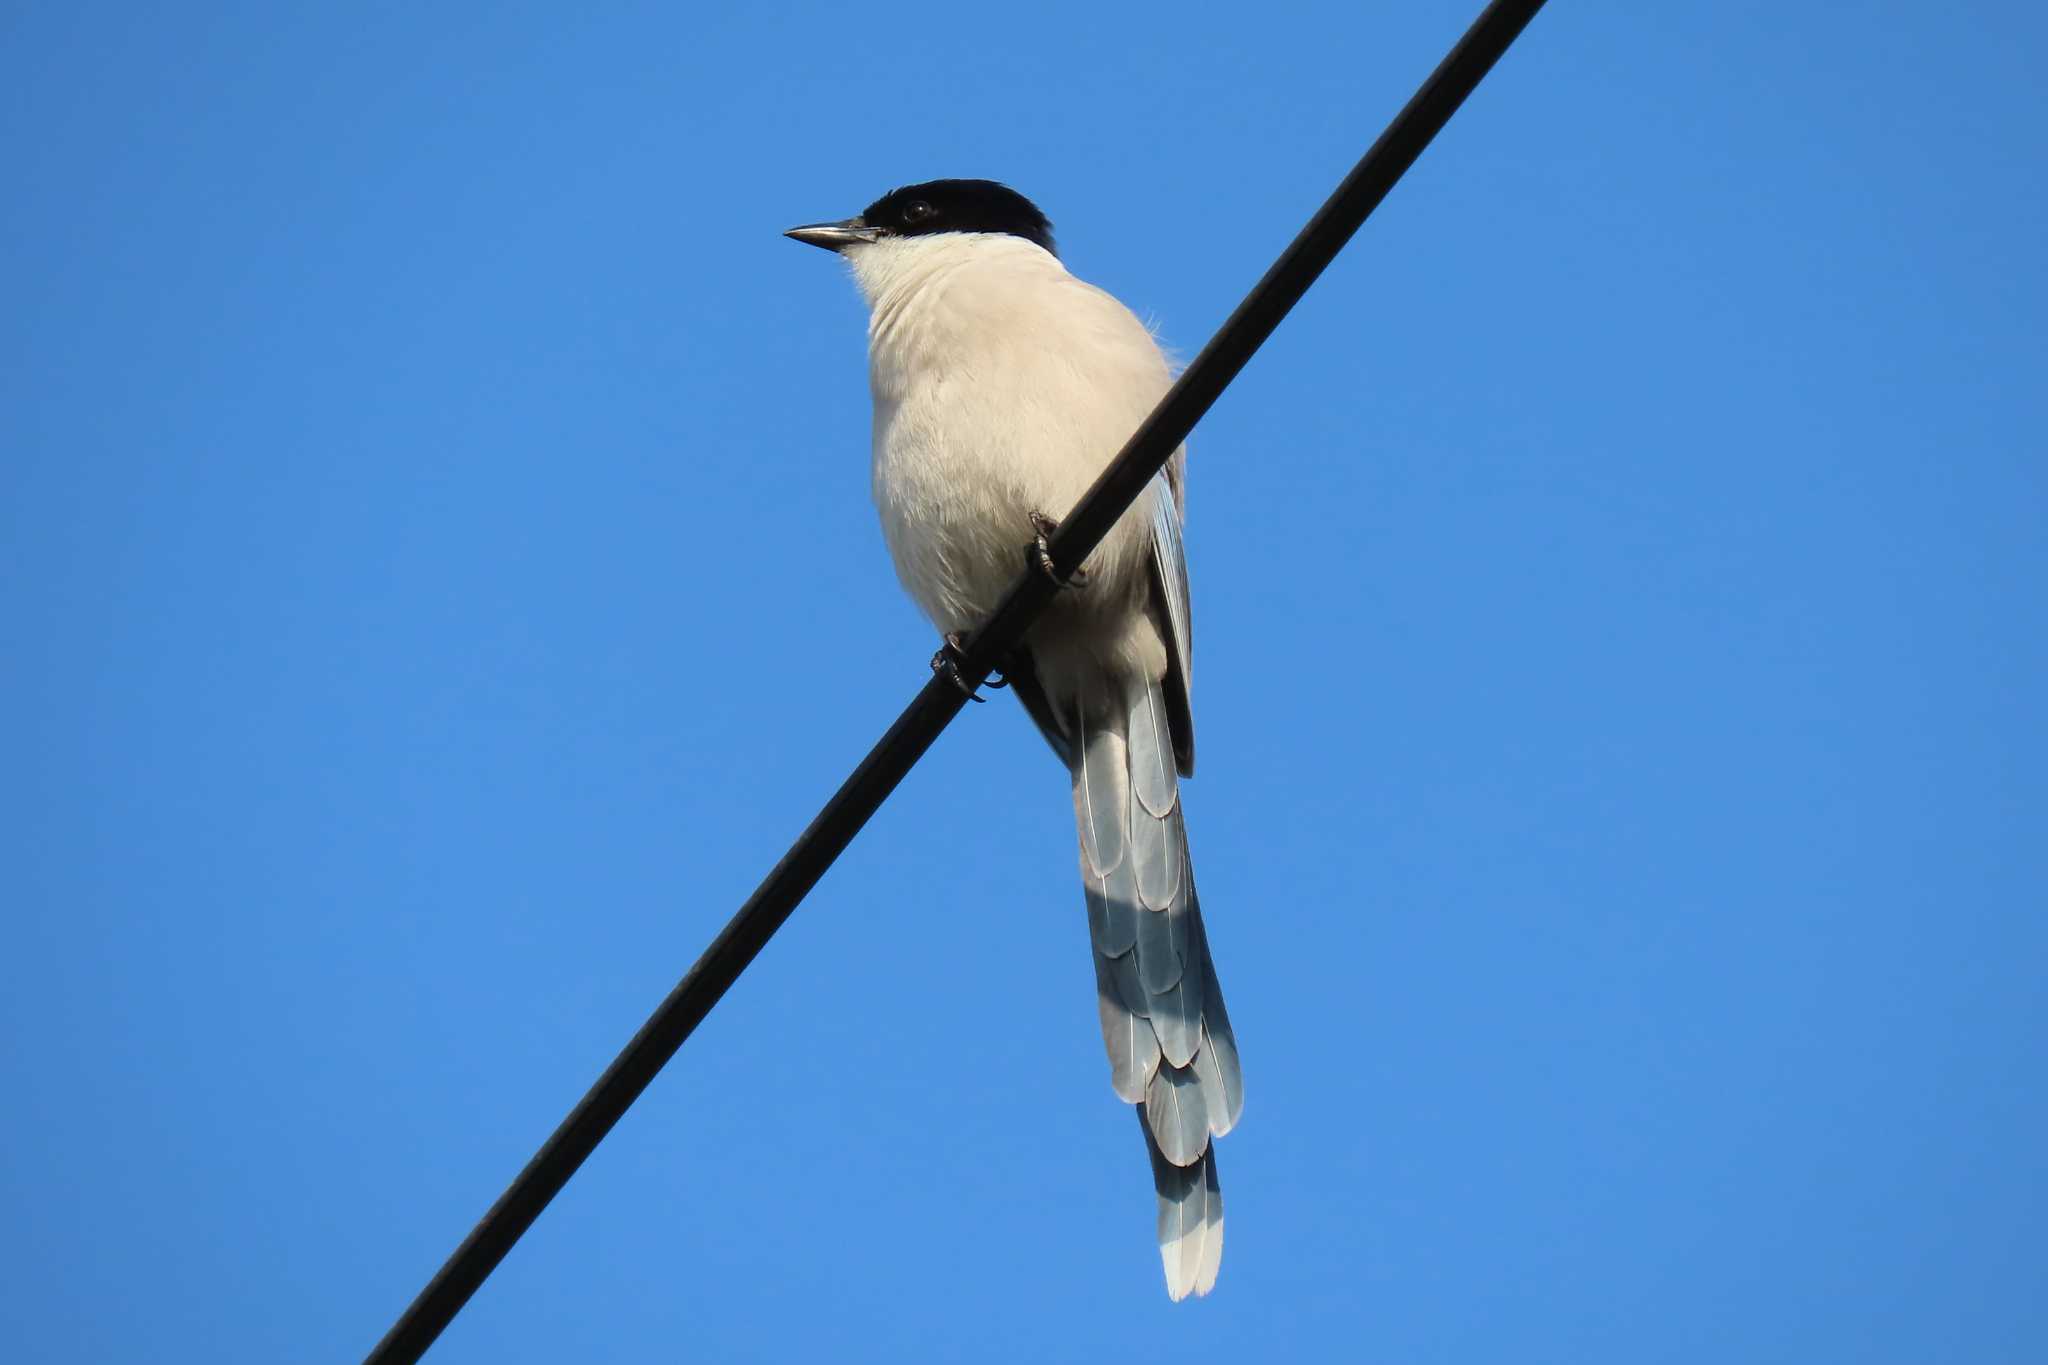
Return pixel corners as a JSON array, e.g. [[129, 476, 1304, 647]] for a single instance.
[[784, 180, 1243, 1302]]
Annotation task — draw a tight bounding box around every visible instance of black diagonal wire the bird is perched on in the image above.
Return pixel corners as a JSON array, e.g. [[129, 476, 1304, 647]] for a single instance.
[[367, 0, 1542, 1365]]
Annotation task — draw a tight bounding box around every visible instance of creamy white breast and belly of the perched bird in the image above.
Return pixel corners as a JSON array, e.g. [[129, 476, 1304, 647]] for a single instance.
[[848, 233, 1171, 630]]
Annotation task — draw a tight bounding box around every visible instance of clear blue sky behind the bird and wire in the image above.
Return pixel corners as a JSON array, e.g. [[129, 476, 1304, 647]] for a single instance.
[[0, 0, 2048, 1365]]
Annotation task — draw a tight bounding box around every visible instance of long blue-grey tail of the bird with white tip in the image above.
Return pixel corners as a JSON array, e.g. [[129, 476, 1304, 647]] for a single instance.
[[1071, 677, 1245, 1302]]
